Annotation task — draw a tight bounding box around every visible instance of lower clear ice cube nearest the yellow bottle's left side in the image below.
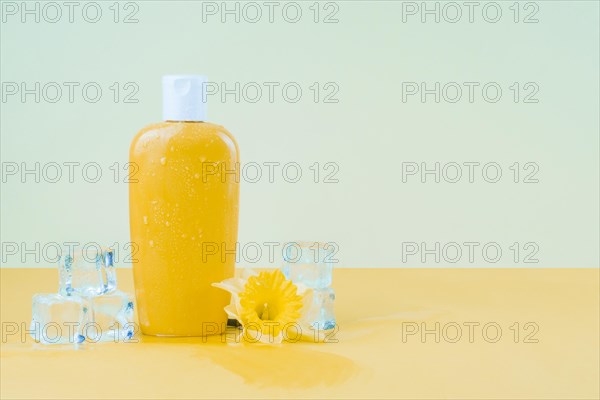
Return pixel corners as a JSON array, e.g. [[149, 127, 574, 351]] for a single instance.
[[85, 290, 135, 342]]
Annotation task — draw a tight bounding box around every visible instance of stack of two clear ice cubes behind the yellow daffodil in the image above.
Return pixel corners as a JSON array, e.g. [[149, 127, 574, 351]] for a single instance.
[[282, 242, 336, 330]]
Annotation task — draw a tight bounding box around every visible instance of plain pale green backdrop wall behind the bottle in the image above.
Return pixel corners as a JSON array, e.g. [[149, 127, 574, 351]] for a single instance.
[[0, 1, 600, 268]]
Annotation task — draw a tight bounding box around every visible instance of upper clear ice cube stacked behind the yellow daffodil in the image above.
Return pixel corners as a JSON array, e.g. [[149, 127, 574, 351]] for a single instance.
[[282, 242, 335, 289]]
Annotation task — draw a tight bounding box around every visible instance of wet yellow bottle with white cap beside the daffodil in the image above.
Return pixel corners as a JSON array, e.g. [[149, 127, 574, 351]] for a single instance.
[[129, 75, 239, 336]]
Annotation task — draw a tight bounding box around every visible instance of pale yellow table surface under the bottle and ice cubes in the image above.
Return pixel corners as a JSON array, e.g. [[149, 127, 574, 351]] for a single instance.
[[0, 269, 600, 399]]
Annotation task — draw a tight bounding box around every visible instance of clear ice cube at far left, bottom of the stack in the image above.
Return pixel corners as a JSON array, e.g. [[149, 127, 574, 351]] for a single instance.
[[30, 293, 89, 344]]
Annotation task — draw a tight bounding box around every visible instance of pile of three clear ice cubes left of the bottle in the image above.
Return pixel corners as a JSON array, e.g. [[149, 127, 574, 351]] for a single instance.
[[30, 248, 134, 345]]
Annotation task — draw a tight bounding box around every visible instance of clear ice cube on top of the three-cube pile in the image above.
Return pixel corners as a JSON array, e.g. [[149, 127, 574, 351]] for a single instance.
[[58, 247, 117, 296]]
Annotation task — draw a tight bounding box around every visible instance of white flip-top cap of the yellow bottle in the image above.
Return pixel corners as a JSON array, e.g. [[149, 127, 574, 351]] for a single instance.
[[163, 75, 207, 121]]
